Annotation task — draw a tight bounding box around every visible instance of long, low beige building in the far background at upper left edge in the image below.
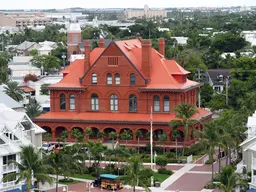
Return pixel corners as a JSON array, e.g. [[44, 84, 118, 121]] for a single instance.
[[0, 12, 51, 27]]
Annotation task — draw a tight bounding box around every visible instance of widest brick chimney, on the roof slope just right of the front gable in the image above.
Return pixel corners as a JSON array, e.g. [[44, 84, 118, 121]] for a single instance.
[[141, 39, 152, 78]]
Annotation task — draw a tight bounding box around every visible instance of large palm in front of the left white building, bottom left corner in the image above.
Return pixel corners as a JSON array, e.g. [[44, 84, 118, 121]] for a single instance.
[[3, 145, 53, 192]]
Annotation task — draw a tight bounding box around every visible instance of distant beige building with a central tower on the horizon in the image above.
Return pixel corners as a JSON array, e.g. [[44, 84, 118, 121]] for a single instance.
[[124, 5, 167, 19]]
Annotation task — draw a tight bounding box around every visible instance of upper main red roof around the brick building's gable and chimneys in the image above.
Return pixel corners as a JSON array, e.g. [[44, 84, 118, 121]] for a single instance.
[[50, 39, 199, 90]]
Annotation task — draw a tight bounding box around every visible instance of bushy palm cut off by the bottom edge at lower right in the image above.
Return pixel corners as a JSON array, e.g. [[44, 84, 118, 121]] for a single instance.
[[215, 166, 248, 192]]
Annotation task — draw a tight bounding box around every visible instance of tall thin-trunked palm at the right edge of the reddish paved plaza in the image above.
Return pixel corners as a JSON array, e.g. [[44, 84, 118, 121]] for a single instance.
[[198, 121, 219, 182]]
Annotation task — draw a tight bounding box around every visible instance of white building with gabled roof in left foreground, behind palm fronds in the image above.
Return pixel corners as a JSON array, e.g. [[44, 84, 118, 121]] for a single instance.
[[0, 104, 45, 191]]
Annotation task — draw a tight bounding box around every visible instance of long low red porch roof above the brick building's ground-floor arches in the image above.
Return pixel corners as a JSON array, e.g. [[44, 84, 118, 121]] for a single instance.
[[36, 108, 211, 123]]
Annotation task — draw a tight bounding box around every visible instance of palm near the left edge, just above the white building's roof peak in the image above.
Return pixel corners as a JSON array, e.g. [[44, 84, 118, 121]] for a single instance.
[[4, 81, 24, 102]]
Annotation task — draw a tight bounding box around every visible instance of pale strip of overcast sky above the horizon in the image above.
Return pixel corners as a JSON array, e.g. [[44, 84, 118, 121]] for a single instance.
[[0, 0, 256, 9]]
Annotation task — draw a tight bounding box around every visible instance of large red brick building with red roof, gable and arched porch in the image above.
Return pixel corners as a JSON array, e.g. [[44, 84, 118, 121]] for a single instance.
[[35, 39, 211, 147]]
